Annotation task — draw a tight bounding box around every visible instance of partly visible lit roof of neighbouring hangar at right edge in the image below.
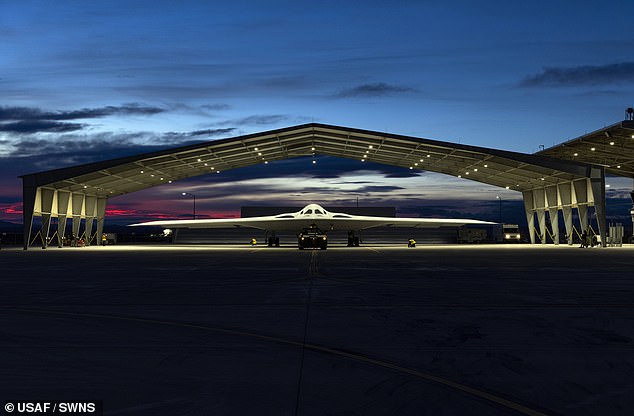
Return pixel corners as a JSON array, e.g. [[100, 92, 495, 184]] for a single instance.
[[536, 120, 634, 178]]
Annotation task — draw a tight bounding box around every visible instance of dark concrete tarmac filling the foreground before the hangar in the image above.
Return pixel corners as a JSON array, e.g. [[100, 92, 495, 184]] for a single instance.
[[0, 245, 634, 415]]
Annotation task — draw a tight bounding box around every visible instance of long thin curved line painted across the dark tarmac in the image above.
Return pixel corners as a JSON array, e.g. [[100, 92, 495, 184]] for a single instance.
[[0, 306, 547, 416]]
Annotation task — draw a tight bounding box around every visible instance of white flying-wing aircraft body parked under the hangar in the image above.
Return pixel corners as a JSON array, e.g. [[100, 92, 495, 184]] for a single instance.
[[133, 204, 495, 233]]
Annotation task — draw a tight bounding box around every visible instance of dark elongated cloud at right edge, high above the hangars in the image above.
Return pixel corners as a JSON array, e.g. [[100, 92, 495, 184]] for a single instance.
[[520, 62, 634, 87]]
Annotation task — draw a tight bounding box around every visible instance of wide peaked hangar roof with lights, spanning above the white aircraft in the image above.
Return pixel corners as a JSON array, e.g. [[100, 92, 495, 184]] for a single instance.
[[21, 123, 592, 197]]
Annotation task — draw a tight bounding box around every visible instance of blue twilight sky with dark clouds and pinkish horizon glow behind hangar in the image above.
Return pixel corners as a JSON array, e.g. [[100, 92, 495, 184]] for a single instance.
[[0, 0, 634, 222]]
